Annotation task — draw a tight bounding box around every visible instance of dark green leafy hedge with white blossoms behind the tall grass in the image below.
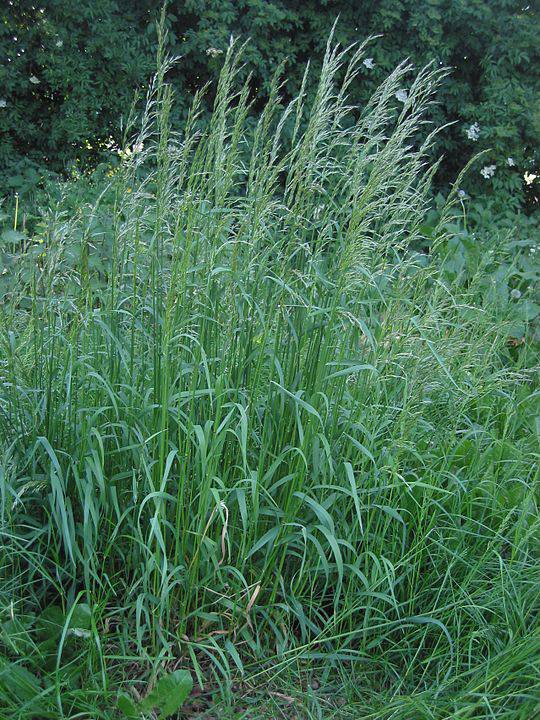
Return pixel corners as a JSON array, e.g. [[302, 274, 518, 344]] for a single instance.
[[0, 0, 540, 208]]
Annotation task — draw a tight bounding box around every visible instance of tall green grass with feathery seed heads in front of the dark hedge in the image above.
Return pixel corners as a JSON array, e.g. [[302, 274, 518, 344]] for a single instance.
[[0, 22, 540, 720]]
